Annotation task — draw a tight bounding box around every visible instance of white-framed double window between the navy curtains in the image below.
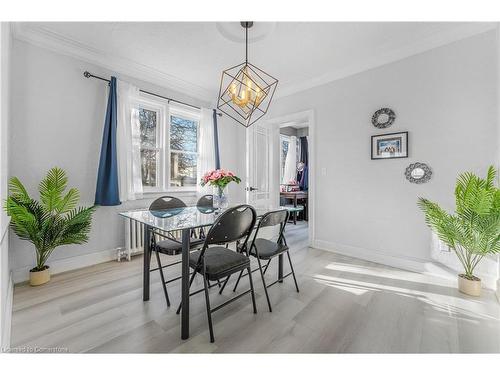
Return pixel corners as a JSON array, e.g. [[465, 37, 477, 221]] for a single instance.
[[135, 98, 200, 192]]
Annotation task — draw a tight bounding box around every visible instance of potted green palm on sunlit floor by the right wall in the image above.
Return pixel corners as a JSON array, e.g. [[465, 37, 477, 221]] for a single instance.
[[418, 166, 500, 296]]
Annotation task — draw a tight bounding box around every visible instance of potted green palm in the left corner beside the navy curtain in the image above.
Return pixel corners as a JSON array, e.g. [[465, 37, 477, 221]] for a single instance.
[[5, 168, 94, 286]]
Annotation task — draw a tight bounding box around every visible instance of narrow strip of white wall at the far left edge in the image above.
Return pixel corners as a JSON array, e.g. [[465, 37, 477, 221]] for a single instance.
[[0, 22, 13, 348]]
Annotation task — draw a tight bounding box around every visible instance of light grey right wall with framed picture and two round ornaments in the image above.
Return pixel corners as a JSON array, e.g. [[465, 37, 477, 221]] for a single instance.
[[270, 31, 498, 286]]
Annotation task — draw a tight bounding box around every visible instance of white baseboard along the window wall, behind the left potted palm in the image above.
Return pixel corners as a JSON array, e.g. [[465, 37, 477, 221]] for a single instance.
[[13, 248, 121, 284]]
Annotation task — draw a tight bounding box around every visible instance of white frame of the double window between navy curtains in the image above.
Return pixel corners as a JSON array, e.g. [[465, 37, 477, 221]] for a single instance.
[[133, 96, 201, 194]]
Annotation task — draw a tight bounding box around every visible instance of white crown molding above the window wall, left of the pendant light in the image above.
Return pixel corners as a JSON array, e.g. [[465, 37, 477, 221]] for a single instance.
[[12, 22, 214, 102]]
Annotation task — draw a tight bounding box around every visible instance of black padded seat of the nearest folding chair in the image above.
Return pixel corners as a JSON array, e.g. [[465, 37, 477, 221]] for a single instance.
[[189, 246, 250, 280]]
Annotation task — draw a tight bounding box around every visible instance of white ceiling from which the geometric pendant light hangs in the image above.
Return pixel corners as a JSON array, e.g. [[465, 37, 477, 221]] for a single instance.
[[14, 22, 496, 101]]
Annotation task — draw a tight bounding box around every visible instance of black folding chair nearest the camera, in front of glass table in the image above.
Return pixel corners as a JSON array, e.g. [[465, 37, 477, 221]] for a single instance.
[[177, 205, 257, 342]]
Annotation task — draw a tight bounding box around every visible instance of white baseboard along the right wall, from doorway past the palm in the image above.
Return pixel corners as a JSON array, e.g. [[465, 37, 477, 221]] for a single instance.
[[313, 240, 500, 290]]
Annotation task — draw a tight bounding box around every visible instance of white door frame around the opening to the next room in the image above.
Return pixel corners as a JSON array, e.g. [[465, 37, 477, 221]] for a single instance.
[[265, 109, 316, 247]]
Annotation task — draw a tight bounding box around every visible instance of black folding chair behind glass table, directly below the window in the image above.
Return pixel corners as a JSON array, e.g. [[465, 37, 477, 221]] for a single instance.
[[149, 196, 203, 307]]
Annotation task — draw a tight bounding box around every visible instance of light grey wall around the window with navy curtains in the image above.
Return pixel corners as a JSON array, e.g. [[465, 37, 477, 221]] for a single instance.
[[10, 40, 245, 282]]
